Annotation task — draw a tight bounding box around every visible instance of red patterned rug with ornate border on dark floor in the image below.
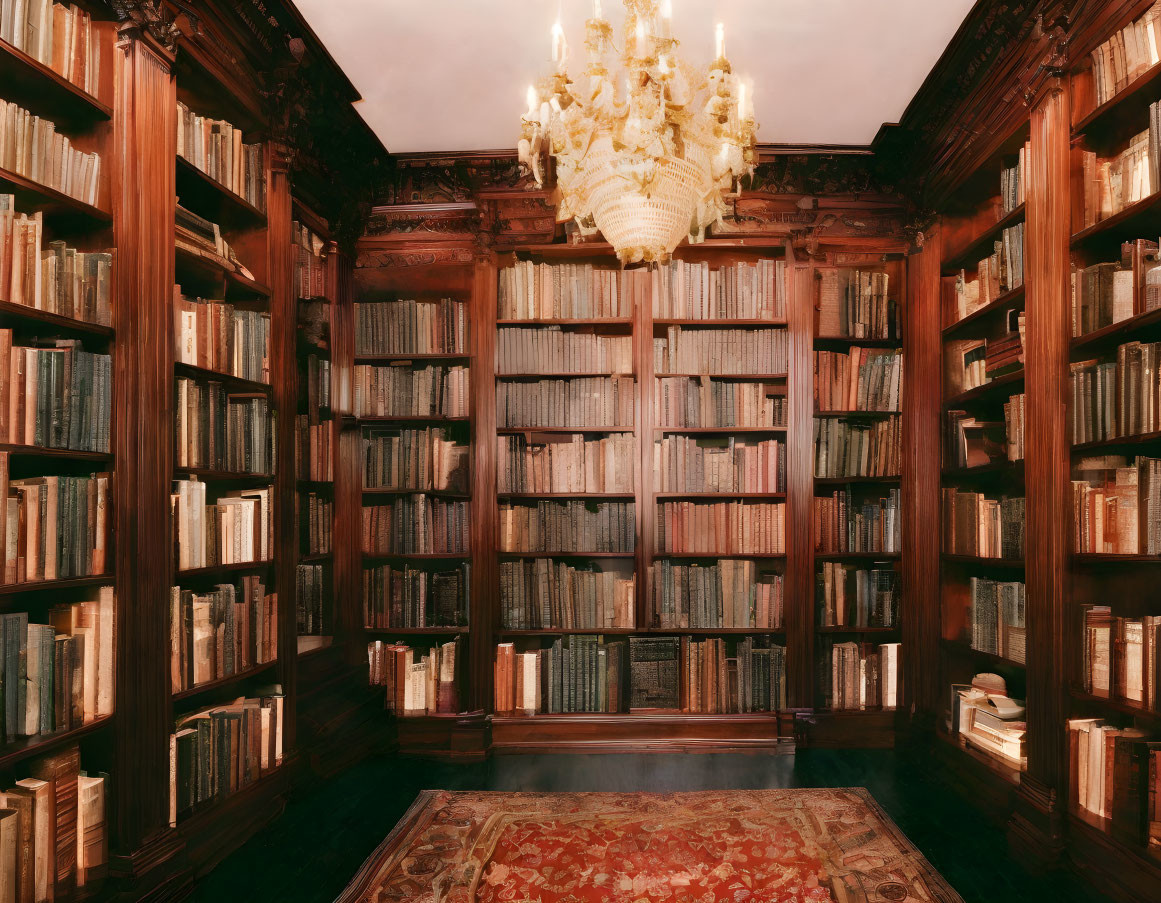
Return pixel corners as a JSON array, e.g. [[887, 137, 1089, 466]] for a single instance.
[[338, 788, 962, 903]]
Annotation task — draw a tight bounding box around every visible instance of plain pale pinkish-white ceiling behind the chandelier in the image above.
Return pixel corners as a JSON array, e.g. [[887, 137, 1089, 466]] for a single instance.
[[297, 0, 974, 153]]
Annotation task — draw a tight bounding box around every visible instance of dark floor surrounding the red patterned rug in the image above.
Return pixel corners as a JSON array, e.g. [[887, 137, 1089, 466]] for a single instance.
[[195, 750, 1106, 903]]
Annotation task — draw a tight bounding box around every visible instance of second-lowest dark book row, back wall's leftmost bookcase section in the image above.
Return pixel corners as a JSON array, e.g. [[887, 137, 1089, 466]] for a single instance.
[[362, 562, 471, 629]]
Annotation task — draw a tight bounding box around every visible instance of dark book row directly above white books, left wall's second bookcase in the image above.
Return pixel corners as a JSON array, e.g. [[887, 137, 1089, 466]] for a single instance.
[[174, 376, 276, 475]]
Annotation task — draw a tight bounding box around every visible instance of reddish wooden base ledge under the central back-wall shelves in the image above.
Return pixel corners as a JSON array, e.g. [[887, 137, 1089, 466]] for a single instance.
[[491, 711, 794, 753]]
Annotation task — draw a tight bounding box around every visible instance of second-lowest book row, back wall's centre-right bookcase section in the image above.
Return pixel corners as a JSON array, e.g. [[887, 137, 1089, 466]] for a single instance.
[[650, 558, 786, 630]]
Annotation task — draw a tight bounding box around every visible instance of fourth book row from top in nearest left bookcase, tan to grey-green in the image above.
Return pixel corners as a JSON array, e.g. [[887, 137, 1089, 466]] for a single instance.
[[0, 330, 113, 453]]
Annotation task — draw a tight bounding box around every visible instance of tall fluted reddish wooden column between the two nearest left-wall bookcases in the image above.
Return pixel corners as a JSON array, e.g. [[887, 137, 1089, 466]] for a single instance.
[[110, 26, 176, 876]]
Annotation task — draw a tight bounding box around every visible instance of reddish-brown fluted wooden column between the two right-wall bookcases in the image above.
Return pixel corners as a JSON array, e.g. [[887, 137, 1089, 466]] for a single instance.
[[1012, 80, 1072, 851]]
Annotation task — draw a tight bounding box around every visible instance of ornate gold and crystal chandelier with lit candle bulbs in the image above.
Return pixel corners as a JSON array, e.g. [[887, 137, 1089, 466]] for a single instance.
[[519, 0, 757, 263]]
